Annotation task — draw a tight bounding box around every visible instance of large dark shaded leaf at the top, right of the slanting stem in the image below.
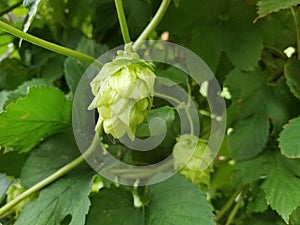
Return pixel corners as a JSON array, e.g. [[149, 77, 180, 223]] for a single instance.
[[160, 0, 262, 71]]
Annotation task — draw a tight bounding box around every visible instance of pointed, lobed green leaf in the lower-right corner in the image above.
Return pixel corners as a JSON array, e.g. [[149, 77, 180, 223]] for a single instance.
[[234, 152, 300, 222]]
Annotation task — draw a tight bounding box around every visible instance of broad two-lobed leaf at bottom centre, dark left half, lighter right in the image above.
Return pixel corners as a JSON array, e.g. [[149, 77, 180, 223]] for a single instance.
[[87, 175, 215, 225]]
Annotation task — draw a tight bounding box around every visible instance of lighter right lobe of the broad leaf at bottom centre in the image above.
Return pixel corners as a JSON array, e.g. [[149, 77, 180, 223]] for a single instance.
[[146, 175, 215, 225]]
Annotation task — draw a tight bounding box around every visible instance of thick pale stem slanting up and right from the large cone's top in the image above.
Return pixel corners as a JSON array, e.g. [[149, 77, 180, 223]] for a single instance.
[[133, 0, 171, 50]]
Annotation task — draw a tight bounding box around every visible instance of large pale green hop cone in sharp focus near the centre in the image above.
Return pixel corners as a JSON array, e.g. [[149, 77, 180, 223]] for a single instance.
[[88, 44, 156, 140]]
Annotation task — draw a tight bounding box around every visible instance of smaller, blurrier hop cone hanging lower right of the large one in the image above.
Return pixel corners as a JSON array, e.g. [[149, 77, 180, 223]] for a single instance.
[[173, 134, 213, 189]]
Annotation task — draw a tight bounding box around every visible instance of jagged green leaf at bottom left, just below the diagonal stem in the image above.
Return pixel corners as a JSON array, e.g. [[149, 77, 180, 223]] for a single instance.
[[15, 170, 92, 225]]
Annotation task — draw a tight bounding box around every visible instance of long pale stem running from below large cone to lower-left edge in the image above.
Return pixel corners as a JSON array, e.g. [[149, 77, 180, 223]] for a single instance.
[[0, 134, 100, 217]]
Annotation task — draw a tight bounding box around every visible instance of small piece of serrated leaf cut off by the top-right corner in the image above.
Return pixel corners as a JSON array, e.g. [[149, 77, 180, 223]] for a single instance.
[[256, 0, 300, 20]]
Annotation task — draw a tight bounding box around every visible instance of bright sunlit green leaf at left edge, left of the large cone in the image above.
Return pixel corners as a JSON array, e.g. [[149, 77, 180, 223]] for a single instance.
[[0, 87, 71, 152]]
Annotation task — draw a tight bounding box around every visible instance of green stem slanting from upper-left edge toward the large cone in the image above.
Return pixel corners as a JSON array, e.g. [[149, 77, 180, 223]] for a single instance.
[[0, 21, 95, 64]]
